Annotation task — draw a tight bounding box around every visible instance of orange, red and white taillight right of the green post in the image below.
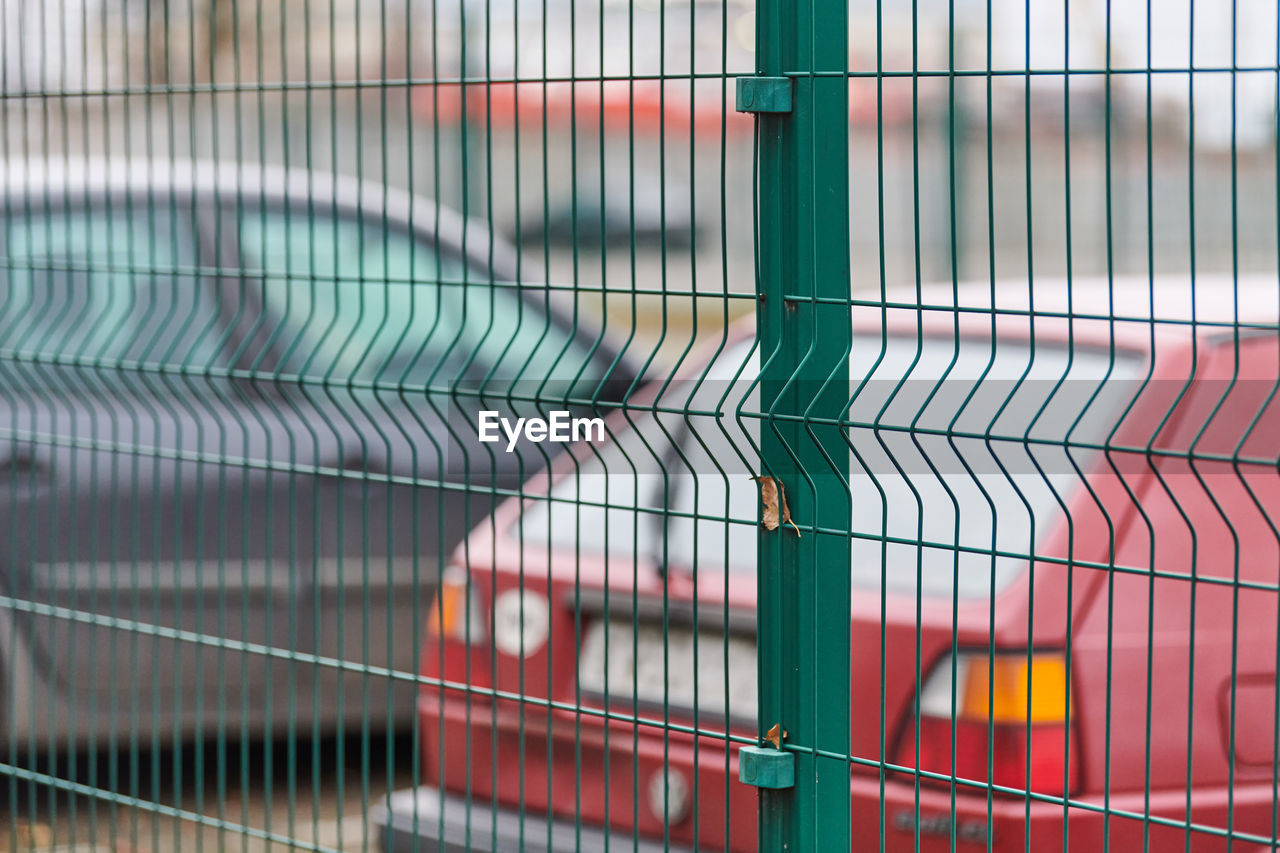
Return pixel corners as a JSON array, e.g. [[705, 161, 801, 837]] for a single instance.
[[896, 652, 1079, 795]]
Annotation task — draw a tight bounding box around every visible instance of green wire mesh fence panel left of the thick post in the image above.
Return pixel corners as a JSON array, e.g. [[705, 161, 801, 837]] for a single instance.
[[0, 0, 756, 850]]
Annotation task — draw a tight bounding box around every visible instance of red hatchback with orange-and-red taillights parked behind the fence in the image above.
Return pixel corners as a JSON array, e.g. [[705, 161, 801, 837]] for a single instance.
[[375, 277, 1280, 853]]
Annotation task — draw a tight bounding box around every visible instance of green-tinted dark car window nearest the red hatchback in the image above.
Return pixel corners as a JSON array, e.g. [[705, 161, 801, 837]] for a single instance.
[[239, 210, 602, 387]]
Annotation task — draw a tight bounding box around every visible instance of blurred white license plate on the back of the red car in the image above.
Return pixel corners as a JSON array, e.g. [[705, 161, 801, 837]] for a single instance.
[[577, 619, 758, 720]]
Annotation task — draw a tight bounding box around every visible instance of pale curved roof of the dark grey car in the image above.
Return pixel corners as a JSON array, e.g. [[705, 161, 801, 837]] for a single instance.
[[0, 158, 520, 282]]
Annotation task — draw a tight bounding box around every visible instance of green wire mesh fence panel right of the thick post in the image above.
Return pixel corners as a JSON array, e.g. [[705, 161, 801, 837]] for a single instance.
[[819, 1, 1280, 850]]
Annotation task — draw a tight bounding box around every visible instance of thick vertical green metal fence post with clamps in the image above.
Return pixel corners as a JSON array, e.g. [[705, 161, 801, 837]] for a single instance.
[[739, 0, 852, 852]]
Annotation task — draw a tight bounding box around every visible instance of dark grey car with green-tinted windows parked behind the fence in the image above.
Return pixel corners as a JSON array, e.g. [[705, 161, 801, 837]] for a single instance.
[[0, 159, 635, 754]]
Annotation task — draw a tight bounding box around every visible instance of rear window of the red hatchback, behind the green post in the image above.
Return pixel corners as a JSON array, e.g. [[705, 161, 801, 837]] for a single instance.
[[520, 336, 1142, 598]]
